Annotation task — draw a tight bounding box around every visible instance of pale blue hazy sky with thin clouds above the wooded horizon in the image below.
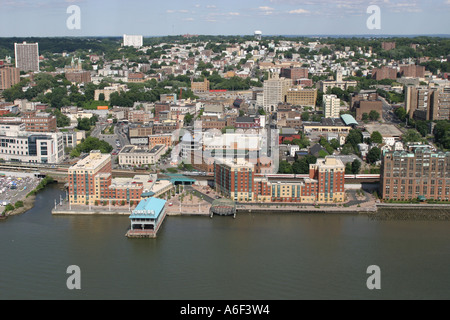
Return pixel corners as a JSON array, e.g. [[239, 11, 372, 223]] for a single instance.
[[0, 0, 450, 37]]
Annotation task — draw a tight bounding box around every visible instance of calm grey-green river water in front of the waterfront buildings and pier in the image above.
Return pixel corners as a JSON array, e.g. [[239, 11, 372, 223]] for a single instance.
[[0, 186, 450, 300]]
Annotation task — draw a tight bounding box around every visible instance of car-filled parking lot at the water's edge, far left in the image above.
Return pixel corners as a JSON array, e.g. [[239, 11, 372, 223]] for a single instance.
[[0, 172, 40, 212]]
